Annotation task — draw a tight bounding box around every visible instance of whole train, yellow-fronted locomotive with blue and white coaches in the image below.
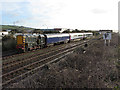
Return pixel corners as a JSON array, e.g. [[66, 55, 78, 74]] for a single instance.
[[16, 33, 93, 52]]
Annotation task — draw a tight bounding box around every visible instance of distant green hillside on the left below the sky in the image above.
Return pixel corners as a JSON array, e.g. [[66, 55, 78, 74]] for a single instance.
[[0, 25, 34, 32]]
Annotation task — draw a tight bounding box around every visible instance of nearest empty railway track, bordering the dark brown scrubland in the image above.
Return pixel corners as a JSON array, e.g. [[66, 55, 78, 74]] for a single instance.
[[0, 40, 93, 87]]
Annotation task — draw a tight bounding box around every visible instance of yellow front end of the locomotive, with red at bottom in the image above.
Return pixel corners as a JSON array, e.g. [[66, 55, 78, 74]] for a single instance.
[[16, 35, 25, 52]]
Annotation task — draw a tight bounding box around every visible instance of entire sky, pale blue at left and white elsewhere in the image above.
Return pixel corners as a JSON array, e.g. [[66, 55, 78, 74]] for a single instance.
[[0, 0, 119, 30]]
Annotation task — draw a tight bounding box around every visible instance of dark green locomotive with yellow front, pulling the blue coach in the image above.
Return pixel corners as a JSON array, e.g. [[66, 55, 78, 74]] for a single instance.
[[16, 34, 45, 52]]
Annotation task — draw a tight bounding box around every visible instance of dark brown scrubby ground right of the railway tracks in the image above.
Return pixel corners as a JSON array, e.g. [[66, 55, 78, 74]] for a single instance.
[[8, 34, 120, 88]]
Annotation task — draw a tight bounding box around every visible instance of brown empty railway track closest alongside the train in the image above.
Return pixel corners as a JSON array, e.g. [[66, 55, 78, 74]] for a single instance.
[[2, 40, 78, 67]]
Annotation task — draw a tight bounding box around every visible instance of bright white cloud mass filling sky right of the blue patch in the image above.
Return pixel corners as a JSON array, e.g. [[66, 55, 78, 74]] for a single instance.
[[20, 0, 117, 29]]
